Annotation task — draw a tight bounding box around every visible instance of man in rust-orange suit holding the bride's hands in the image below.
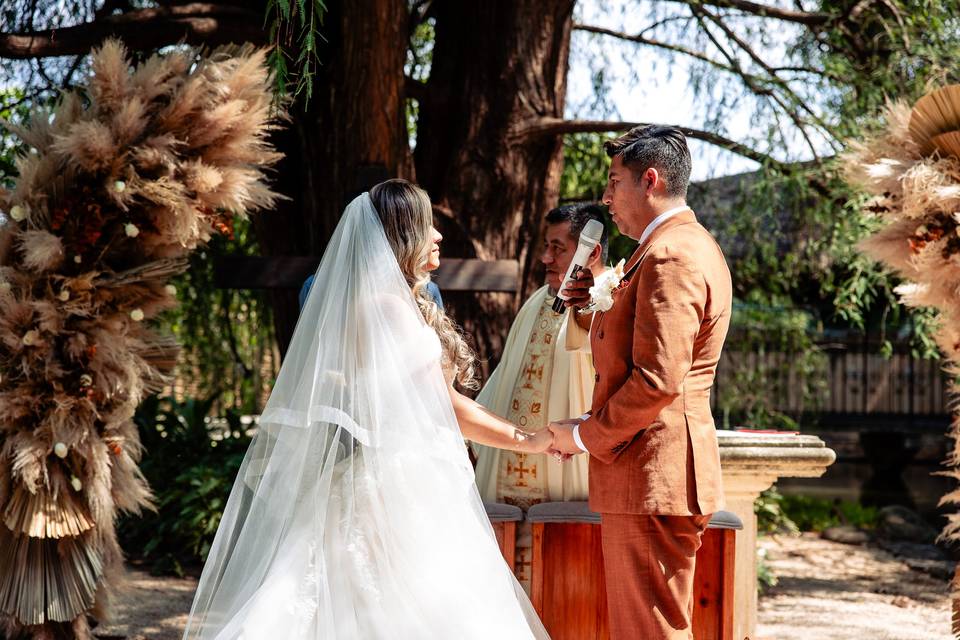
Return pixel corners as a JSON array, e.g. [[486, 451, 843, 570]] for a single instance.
[[550, 125, 732, 640]]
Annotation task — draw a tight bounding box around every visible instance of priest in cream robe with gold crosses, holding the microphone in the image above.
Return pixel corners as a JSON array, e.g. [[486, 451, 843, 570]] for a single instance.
[[474, 203, 607, 591]]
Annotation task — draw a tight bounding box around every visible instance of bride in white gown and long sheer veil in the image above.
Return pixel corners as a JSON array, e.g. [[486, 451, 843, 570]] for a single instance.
[[184, 180, 551, 640]]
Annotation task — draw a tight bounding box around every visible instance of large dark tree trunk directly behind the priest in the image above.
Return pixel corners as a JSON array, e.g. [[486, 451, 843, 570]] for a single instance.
[[414, 0, 574, 372]]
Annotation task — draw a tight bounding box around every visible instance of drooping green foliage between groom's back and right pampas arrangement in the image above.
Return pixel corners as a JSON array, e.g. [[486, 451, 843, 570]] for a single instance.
[[708, 161, 938, 358]]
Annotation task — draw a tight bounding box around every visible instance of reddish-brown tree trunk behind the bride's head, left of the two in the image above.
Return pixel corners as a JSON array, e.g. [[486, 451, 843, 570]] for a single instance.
[[257, 0, 412, 351]]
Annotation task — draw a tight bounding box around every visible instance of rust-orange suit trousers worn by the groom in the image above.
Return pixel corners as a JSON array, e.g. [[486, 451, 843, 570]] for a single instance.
[[600, 513, 710, 640]]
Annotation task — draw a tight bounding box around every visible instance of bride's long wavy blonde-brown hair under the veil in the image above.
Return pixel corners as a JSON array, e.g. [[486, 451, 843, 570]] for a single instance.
[[370, 178, 480, 389]]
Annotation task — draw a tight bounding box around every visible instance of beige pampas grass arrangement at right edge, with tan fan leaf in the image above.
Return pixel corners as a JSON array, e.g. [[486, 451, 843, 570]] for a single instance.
[[843, 85, 960, 637]]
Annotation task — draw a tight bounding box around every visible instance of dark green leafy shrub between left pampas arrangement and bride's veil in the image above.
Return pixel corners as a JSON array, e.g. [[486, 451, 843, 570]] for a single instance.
[[118, 397, 250, 575]]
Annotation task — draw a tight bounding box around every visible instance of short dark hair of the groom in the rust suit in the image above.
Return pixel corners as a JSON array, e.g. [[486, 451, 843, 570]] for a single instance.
[[603, 124, 690, 198]]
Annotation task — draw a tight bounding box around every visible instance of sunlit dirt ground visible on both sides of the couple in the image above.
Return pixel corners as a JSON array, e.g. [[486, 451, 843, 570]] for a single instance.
[[96, 534, 951, 640]]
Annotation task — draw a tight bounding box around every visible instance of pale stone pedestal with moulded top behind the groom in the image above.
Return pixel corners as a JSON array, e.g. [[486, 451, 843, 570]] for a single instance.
[[717, 431, 837, 640]]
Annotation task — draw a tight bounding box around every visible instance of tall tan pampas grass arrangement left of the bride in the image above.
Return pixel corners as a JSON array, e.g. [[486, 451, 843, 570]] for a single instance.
[[0, 41, 280, 638]]
